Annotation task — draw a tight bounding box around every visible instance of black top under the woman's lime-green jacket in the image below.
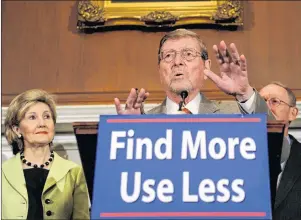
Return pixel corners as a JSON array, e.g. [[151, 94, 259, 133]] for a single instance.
[[23, 168, 49, 220]]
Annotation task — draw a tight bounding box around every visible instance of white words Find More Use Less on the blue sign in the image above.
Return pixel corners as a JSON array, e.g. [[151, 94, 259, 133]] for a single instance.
[[109, 129, 256, 203]]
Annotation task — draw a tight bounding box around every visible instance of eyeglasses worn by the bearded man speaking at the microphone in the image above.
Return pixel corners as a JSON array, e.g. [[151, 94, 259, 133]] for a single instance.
[[160, 48, 208, 63]]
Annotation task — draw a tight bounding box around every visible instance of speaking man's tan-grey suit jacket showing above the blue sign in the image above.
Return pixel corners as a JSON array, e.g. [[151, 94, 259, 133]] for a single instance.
[[146, 91, 275, 117]]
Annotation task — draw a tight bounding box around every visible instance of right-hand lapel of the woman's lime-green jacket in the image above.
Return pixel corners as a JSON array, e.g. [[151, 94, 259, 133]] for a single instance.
[[43, 152, 76, 194]]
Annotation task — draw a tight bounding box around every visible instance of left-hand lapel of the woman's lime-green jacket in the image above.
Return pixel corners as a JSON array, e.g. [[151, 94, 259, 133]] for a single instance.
[[2, 153, 28, 201]]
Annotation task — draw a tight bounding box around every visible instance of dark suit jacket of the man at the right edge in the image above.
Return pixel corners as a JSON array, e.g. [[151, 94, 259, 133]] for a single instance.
[[273, 135, 301, 220]]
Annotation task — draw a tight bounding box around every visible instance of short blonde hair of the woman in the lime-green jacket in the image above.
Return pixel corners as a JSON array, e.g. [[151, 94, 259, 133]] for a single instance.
[[4, 89, 57, 154]]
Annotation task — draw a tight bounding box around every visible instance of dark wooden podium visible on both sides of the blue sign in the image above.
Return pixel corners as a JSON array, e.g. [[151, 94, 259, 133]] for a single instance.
[[72, 121, 285, 208]]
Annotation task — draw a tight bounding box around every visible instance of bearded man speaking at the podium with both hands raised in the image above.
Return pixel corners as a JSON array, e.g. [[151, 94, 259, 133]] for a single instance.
[[114, 29, 268, 114]]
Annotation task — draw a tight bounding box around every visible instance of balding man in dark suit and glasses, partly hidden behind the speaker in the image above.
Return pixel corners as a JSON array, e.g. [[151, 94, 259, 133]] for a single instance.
[[259, 82, 301, 220]]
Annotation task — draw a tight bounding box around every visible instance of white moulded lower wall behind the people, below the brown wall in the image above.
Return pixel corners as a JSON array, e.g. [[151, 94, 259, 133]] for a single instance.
[[1, 102, 301, 164]]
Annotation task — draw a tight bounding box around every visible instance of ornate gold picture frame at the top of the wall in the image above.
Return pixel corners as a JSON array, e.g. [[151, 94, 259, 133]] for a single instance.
[[77, 0, 243, 29]]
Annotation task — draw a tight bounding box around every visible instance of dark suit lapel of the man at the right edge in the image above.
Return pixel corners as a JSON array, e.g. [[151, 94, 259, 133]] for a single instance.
[[275, 136, 301, 209]]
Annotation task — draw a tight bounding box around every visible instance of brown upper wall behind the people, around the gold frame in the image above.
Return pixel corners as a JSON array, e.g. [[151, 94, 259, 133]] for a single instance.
[[2, 1, 301, 106]]
